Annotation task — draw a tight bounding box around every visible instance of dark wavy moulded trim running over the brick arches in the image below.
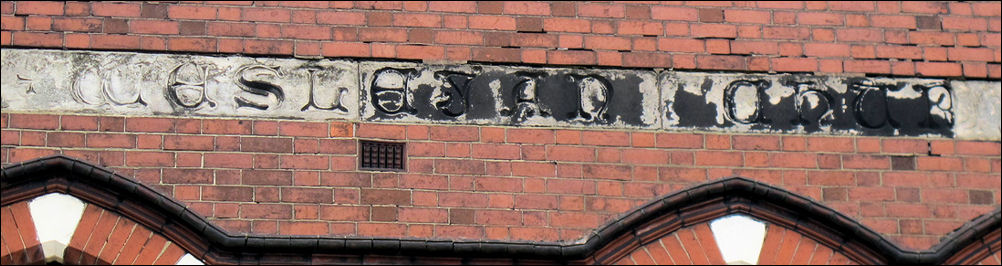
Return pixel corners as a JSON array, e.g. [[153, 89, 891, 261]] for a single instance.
[[0, 156, 1002, 264]]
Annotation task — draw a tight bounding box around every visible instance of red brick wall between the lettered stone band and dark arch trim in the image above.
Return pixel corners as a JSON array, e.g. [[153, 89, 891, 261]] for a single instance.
[[0, 113, 1002, 249]]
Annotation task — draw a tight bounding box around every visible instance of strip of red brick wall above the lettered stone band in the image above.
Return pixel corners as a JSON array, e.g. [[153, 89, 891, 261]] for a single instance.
[[0, 1, 1002, 78]]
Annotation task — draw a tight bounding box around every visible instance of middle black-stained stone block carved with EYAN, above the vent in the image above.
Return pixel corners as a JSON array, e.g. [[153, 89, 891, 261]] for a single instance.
[[360, 62, 660, 128]]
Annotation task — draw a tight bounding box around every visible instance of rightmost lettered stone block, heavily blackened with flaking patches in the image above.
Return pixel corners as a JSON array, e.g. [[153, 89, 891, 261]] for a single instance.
[[661, 72, 973, 138]]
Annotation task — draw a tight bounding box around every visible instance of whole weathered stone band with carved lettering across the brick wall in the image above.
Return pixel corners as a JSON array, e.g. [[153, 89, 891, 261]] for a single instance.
[[2, 49, 1002, 141]]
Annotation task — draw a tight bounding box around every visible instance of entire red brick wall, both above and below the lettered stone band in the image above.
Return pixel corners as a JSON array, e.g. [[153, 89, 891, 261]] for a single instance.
[[0, 1, 1002, 256]]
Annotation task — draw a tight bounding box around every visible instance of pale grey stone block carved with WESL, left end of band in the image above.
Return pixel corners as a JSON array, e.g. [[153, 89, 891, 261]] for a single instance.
[[2, 49, 359, 119]]
